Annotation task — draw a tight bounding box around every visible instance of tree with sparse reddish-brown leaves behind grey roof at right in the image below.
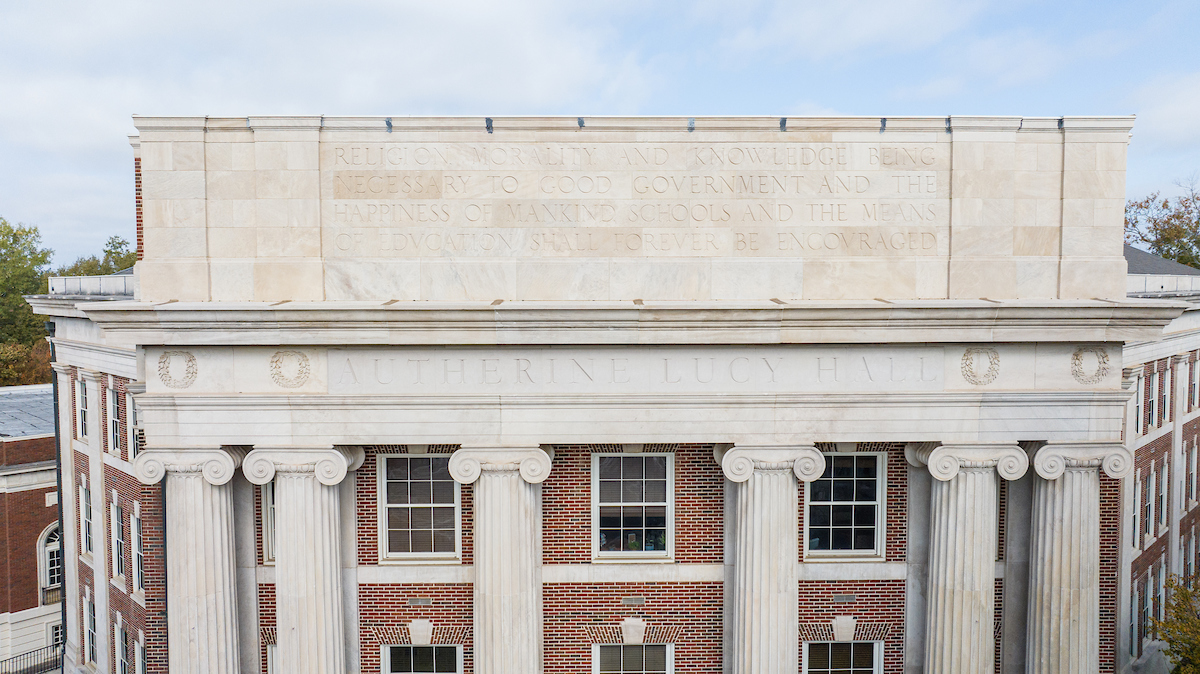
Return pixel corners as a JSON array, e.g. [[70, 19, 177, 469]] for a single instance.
[[1126, 179, 1200, 267]]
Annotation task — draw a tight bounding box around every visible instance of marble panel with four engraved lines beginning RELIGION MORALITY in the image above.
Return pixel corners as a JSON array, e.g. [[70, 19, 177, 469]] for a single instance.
[[322, 142, 949, 257]]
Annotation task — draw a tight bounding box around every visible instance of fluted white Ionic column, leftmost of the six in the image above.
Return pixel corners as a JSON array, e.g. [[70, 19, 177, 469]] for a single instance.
[[134, 449, 245, 674]]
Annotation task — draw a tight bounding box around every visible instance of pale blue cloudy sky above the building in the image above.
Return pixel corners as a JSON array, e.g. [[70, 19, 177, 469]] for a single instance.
[[0, 0, 1200, 263]]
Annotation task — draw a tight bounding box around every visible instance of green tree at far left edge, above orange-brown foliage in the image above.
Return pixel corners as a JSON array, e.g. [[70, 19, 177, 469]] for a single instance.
[[0, 217, 53, 347]]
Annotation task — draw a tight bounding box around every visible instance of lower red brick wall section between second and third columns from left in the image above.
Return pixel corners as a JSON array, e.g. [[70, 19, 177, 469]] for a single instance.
[[359, 583, 470, 673]]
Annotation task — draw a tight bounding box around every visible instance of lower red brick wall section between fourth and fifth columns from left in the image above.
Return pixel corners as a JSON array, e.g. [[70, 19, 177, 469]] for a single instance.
[[799, 580, 905, 674]]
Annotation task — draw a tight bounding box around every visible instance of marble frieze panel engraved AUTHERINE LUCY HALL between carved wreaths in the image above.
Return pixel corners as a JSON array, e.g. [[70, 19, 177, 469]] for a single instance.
[[329, 348, 943, 393]]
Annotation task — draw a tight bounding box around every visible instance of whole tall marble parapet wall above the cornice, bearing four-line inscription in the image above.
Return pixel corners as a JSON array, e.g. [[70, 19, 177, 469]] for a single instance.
[[129, 116, 1133, 301]]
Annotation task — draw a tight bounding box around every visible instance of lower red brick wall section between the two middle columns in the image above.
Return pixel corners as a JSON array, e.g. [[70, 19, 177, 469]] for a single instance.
[[544, 580, 724, 674]]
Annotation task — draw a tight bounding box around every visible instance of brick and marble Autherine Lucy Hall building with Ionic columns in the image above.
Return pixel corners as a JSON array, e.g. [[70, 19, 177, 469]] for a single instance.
[[30, 116, 1186, 674]]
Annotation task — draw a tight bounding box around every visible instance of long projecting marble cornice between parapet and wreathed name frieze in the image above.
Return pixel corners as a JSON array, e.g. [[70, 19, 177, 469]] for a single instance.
[[65, 300, 1188, 345]]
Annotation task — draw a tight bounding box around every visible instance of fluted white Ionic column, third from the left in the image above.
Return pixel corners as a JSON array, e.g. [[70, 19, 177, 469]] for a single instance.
[[450, 447, 551, 674]]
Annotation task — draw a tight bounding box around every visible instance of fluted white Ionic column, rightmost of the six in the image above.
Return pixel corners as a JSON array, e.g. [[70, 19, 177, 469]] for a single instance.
[[1025, 443, 1133, 674]]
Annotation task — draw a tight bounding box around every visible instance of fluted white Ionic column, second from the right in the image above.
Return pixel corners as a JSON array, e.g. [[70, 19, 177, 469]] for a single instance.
[[905, 443, 1030, 674]]
